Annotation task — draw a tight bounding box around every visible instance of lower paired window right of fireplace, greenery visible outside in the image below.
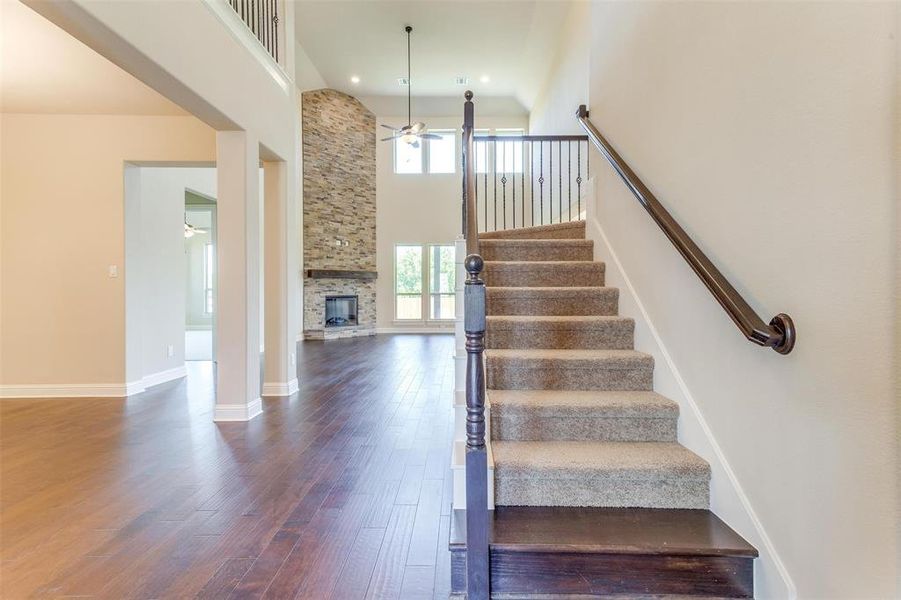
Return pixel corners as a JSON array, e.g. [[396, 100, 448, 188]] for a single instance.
[[394, 244, 456, 321]]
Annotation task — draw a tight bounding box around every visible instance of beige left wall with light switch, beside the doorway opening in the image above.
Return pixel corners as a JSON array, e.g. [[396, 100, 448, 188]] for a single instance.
[[0, 114, 215, 385]]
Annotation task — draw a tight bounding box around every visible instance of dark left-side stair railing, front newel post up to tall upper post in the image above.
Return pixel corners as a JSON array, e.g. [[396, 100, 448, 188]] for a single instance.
[[463, 91, 489, 600]]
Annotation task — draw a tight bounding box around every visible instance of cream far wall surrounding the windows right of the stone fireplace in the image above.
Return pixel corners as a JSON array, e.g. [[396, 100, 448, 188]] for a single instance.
[[376, 114, 528, 331]]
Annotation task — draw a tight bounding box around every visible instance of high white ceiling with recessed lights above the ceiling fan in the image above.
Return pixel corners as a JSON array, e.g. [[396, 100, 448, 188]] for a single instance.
[[296, 0, 570, 117]]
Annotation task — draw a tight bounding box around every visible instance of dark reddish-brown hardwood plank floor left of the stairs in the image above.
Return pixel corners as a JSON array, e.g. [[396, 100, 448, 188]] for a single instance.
[[0, 335, 453, 600]]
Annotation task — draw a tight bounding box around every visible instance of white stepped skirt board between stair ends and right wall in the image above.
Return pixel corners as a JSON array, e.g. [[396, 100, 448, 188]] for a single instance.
[[582, 177, 797, 600]]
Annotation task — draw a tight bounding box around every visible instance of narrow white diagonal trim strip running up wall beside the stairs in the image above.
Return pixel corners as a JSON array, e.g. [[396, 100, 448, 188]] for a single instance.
[[586, 188, 798, 600]]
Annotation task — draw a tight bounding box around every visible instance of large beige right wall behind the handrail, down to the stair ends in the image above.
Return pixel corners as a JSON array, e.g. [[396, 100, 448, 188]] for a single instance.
[[532, 2, 901, 598]]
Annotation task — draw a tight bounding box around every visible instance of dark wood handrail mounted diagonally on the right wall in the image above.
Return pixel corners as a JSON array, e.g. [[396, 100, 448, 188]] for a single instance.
[[576, 104, 796, 354]]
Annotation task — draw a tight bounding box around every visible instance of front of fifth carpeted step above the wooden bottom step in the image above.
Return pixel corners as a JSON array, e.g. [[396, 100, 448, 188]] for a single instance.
[[485, 286, 619, 316]]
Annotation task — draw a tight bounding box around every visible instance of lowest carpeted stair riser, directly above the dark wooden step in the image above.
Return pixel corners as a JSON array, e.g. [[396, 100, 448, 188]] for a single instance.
[[494, 476, 710, 509]]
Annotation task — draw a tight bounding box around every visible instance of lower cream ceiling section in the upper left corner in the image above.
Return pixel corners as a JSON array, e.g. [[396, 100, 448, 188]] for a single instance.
[[0, 0, 187, 115]]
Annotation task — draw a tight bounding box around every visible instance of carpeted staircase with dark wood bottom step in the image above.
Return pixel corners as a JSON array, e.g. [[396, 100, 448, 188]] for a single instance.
[[451, 221, 757, 598]]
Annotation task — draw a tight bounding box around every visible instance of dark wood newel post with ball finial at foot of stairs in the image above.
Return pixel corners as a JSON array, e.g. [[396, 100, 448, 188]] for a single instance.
[[463, 254, 488, 600]]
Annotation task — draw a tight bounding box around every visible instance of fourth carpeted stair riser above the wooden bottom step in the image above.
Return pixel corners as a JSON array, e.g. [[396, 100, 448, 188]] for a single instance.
[[486, 321, 634, 350]]
